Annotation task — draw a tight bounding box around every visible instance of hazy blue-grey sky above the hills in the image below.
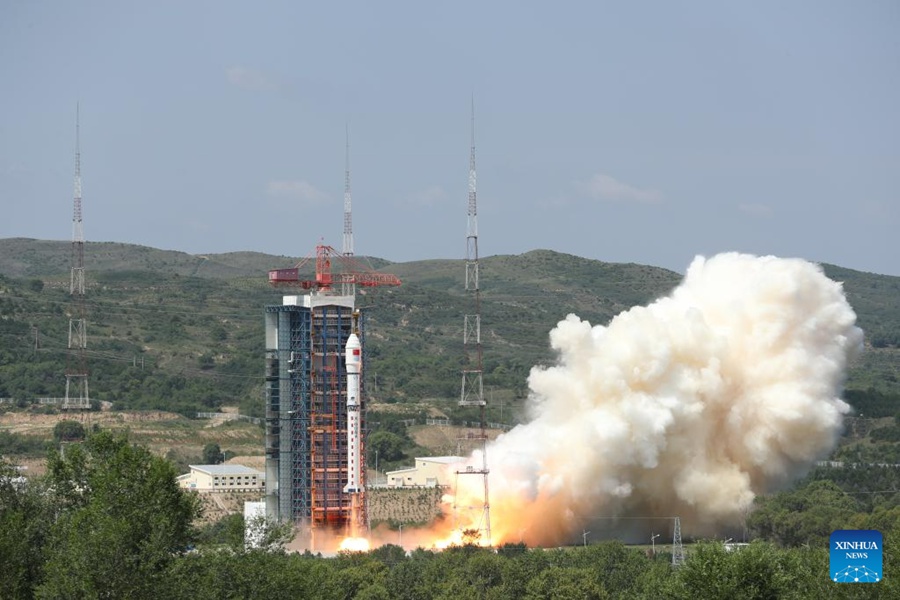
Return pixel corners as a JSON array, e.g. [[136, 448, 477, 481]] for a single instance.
[[0, 0, 900, 275]]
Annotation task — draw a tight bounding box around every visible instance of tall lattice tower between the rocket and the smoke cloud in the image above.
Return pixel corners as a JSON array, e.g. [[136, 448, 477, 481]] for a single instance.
[[457, 97, 491, 546]]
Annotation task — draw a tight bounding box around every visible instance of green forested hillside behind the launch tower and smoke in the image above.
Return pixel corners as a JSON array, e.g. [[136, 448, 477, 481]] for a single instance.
[[0, 238, 900, 421]]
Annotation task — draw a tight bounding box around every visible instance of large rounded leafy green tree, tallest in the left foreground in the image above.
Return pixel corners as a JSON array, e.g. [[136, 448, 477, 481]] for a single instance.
[[37, 431, 200, 598]]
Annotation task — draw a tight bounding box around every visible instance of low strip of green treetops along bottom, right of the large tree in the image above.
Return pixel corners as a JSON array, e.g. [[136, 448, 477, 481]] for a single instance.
[[157, 542, 900, 600]]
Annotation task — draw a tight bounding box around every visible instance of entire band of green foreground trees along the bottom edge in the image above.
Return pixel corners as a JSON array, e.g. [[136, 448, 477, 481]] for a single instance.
[[0, 431, 900, 600]]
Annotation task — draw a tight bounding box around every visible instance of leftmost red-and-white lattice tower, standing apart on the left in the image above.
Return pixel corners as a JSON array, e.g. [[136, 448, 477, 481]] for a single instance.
[[62, 104, 91, 410]]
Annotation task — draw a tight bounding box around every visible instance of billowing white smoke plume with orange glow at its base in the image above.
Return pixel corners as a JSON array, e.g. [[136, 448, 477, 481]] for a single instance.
[[456, 253, 863, 545]]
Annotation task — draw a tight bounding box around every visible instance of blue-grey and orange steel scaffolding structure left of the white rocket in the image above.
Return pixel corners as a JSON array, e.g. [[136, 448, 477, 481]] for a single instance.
[[266, 303, 365, 534]]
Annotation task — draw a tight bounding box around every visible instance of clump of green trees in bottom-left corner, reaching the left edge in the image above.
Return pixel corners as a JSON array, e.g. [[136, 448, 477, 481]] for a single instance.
[[0, 432, 199, 598]]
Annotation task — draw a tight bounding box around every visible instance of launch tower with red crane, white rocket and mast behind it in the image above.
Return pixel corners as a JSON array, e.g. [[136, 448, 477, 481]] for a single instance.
[[265, 136, 400, 547]]
